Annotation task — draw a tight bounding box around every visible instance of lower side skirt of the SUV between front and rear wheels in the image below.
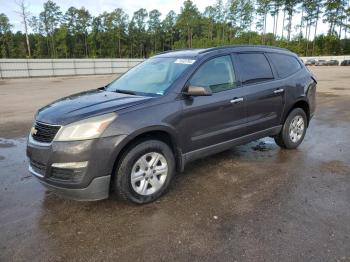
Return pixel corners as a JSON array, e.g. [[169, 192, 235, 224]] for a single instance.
[[180, 125, 282, 168]]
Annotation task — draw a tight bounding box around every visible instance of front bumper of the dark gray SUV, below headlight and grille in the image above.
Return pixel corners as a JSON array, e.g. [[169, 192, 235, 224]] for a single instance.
[[27, 135, 126, 201]]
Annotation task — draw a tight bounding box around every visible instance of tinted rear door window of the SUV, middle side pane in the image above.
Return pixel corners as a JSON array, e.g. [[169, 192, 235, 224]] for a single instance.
[[237, 53, 273, 84]]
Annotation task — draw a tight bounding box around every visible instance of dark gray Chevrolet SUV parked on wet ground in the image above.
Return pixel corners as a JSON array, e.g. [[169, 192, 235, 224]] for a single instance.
[[27, 46, 316, 203]]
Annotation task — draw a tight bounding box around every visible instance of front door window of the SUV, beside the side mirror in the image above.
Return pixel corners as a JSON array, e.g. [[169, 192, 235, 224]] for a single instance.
[[190, 55, 236, 93]]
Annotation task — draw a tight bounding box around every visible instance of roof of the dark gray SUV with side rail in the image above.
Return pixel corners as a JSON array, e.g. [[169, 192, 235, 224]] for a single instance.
[[154, 45, 295, 58]]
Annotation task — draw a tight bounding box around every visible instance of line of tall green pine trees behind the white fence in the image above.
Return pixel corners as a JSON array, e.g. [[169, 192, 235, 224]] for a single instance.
[[0, 0, 350, 58]]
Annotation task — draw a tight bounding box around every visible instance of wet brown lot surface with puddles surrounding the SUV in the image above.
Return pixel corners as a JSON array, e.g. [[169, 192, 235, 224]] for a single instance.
[[0, 67, 350, 262]]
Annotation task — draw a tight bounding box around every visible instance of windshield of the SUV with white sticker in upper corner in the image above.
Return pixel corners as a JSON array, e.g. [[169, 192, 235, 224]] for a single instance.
[[106, 57, 195, 96]]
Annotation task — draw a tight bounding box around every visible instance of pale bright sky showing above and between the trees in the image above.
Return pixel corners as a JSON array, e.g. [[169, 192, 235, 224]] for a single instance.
[[0, 0, 327, 35]]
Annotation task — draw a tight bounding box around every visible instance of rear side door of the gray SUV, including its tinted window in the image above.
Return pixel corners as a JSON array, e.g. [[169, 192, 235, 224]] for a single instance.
[[235, 52, 284, 134]]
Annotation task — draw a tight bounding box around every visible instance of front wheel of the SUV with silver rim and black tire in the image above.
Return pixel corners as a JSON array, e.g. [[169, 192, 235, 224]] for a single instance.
[[114, 140, 175, 204]]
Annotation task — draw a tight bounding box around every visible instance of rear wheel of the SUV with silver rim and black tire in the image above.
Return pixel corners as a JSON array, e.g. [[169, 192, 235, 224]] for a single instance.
[[275, 108, 307, 149]]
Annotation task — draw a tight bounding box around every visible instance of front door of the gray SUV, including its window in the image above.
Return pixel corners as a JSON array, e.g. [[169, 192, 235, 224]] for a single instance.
[[180, 55, 246, 153]]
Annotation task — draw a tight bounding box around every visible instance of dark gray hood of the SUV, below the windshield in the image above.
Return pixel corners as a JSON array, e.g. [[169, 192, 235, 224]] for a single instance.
[[36, 89, 152, 125]]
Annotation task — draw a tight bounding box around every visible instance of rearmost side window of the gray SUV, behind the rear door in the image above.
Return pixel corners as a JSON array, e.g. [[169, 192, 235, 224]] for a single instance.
[[269, 54, 301, 78]]
